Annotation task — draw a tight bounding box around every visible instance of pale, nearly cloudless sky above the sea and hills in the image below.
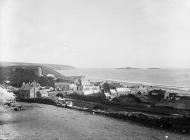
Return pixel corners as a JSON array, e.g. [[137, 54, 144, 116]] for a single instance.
[[0, 0, 190, 68]]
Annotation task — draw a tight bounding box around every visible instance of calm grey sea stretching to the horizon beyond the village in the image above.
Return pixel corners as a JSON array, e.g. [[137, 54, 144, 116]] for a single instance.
[[59, 68, 190, 91]]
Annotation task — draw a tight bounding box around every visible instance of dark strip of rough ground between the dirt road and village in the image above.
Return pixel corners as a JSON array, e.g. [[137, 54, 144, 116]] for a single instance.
[[20, 95, 190, 133]]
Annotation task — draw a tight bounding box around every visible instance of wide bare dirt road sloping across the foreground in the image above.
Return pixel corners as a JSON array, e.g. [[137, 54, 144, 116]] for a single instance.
[[0, 103, 190, 140]]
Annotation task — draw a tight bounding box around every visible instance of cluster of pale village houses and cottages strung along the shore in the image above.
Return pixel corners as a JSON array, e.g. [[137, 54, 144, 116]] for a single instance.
[[17, 74, 183, 99]]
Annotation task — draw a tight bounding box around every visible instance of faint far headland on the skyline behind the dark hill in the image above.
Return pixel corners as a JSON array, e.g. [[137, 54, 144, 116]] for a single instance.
[[0, 62, 76, 70]]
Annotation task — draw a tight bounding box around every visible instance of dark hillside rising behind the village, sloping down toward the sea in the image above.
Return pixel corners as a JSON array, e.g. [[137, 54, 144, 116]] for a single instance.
[[0, 64, 72, 87]]
